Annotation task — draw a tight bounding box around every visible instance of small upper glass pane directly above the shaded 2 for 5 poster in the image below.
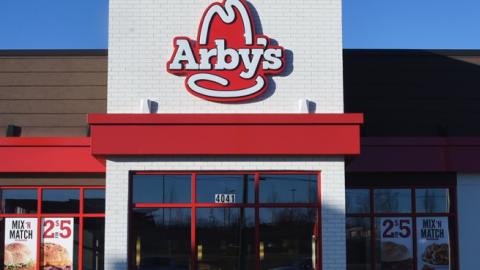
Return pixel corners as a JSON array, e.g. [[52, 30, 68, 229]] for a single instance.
[[374, 189, 412, 213]]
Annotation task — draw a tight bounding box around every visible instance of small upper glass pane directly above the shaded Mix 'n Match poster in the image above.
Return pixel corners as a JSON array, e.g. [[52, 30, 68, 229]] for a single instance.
[[415, 188, 450, 213]]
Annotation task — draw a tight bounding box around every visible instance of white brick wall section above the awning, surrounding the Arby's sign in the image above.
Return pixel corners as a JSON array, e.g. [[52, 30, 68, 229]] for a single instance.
[[108, 0, 343, 113]]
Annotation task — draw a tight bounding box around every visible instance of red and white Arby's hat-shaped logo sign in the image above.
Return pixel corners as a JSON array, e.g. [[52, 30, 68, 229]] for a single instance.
[[167, 0, 285, 102]]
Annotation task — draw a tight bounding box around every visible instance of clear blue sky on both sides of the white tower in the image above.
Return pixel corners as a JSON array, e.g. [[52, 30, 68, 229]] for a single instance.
[[0, 0, 480, 49]]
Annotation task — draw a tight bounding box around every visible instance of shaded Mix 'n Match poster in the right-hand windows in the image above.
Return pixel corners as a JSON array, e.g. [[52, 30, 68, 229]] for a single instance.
[[417, 217, 450, 270]]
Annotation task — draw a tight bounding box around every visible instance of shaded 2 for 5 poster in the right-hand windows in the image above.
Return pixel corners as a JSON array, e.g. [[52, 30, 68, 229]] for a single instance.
[[380, 217, 413, 270]]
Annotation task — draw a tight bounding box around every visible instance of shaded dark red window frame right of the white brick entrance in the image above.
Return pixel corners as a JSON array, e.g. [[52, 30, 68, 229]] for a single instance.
[[345, 181, 459, 270]]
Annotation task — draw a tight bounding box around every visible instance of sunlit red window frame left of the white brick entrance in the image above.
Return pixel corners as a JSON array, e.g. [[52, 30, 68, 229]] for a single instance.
[[0, 186, 105, 270]]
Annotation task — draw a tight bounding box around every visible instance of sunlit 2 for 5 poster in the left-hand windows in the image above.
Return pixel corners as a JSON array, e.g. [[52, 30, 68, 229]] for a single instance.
[[42, 218, 74, 270]]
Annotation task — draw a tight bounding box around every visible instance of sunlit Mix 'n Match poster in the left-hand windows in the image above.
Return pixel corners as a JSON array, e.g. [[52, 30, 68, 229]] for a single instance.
[[4, 218, 37, 270]]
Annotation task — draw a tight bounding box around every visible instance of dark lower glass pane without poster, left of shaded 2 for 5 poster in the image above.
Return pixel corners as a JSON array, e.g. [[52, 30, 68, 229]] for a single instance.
[[346, 217, 372, 270]]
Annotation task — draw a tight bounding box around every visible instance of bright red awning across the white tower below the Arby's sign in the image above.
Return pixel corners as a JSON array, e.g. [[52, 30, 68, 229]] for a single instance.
[[89, 114, 363, 155]]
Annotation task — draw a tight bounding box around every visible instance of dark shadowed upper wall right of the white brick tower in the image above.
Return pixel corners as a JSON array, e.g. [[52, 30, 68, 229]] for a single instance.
[[344, 50, 480, 137]]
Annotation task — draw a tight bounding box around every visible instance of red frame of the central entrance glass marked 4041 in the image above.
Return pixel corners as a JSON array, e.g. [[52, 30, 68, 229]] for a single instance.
[[128, 171, 323, 270]]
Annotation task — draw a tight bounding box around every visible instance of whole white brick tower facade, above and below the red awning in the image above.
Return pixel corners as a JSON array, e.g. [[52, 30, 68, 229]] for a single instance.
[[105, 0, 345, 270]]
